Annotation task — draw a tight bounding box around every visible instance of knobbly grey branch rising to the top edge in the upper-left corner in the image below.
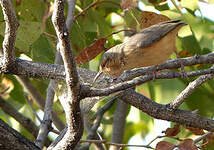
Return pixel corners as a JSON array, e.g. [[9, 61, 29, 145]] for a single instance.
[[0, 0, 19, 66]]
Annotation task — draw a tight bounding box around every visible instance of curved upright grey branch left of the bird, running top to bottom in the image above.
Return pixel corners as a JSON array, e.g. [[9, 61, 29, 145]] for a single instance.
[[49, 0, 83, 150]]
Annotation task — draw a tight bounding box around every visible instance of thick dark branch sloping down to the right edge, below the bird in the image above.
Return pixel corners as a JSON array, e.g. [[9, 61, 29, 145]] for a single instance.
[[118, 89, 214, 131]]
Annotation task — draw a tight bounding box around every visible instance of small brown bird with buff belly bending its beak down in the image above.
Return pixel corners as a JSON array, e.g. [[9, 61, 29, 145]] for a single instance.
[[94, 20, 186, 81]]
